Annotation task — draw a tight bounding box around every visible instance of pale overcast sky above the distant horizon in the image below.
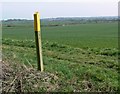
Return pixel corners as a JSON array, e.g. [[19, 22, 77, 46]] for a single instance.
[[0, 0, 118, 19]]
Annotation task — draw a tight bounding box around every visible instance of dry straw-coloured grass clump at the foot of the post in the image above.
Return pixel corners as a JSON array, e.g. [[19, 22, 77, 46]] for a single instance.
[[0, 61, 58, 93]]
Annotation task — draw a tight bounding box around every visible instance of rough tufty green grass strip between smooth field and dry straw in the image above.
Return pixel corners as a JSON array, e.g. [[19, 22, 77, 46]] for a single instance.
[[3, 40, 118, 92]]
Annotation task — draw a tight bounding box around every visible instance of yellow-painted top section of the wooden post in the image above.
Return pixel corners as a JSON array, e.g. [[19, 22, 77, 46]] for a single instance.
[[34, 12, 40, 31]]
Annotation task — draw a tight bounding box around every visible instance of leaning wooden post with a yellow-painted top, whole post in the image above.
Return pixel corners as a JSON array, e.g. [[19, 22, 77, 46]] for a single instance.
[[34, 12, 43, 71]]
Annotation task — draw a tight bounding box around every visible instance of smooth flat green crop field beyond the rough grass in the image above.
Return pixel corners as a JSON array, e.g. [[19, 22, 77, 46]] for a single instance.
[[3, 23, 118, 48]]
